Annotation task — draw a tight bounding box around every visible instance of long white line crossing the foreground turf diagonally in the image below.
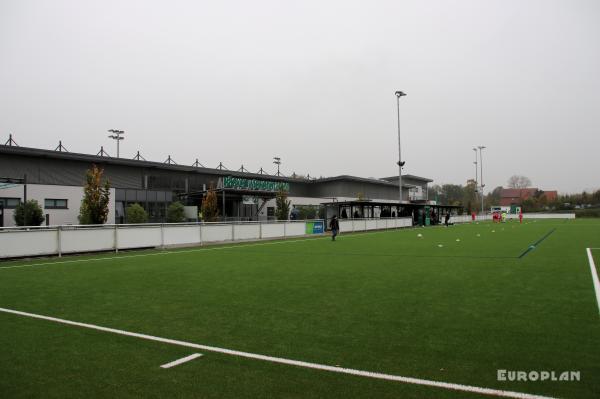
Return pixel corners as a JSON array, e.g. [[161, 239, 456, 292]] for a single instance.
[[0, 308, 552, 399]]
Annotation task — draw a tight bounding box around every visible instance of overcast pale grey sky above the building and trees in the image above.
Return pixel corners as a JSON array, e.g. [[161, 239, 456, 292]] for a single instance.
[[0, 0, 600, 192]]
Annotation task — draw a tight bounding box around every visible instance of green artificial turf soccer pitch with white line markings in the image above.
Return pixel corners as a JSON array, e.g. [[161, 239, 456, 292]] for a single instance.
[[0, 220, 600, 398]]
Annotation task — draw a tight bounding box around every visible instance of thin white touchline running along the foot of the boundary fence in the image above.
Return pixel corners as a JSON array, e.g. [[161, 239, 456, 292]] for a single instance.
[[0, 229, 400, 270]]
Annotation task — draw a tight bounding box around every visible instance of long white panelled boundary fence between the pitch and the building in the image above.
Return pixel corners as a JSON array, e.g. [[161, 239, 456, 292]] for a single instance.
[[0, 218, 412, 259]]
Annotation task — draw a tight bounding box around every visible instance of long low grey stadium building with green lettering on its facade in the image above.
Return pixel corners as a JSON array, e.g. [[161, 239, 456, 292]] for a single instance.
[[0, 145, 446, 227]]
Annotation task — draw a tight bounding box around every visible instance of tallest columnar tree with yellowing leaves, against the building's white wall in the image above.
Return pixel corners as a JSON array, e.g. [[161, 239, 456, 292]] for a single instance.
[[79, 165, 110, 224]]
